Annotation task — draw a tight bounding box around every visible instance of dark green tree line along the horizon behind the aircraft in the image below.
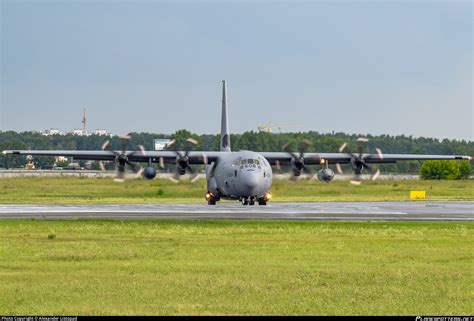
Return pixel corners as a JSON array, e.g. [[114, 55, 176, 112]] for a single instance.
[[0, 129, 474, 174]]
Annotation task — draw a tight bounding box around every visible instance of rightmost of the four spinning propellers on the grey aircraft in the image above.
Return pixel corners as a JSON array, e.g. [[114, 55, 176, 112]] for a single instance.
[[336, 137, 383, 185]]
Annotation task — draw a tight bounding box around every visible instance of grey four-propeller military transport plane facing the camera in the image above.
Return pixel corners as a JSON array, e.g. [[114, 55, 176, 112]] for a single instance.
[[3, 81, 471, 205]]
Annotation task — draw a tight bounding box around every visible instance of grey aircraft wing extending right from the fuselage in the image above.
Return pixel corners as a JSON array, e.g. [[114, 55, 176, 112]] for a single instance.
[[259, 152, 472, 165]]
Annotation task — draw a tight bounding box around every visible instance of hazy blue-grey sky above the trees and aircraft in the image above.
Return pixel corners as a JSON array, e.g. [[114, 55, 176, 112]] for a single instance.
[[0, 0, 474, 140]]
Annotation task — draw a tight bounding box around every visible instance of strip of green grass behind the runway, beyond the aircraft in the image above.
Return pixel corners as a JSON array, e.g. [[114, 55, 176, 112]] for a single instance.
[[0, 177, 474, 204]]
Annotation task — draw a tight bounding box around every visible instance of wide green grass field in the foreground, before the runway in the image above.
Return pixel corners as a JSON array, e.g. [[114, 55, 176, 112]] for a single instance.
[[0, 220, 474, 315]]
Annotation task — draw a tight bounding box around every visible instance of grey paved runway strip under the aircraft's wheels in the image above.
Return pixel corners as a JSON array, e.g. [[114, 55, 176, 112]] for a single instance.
[[0, 202, 474, 221]]
